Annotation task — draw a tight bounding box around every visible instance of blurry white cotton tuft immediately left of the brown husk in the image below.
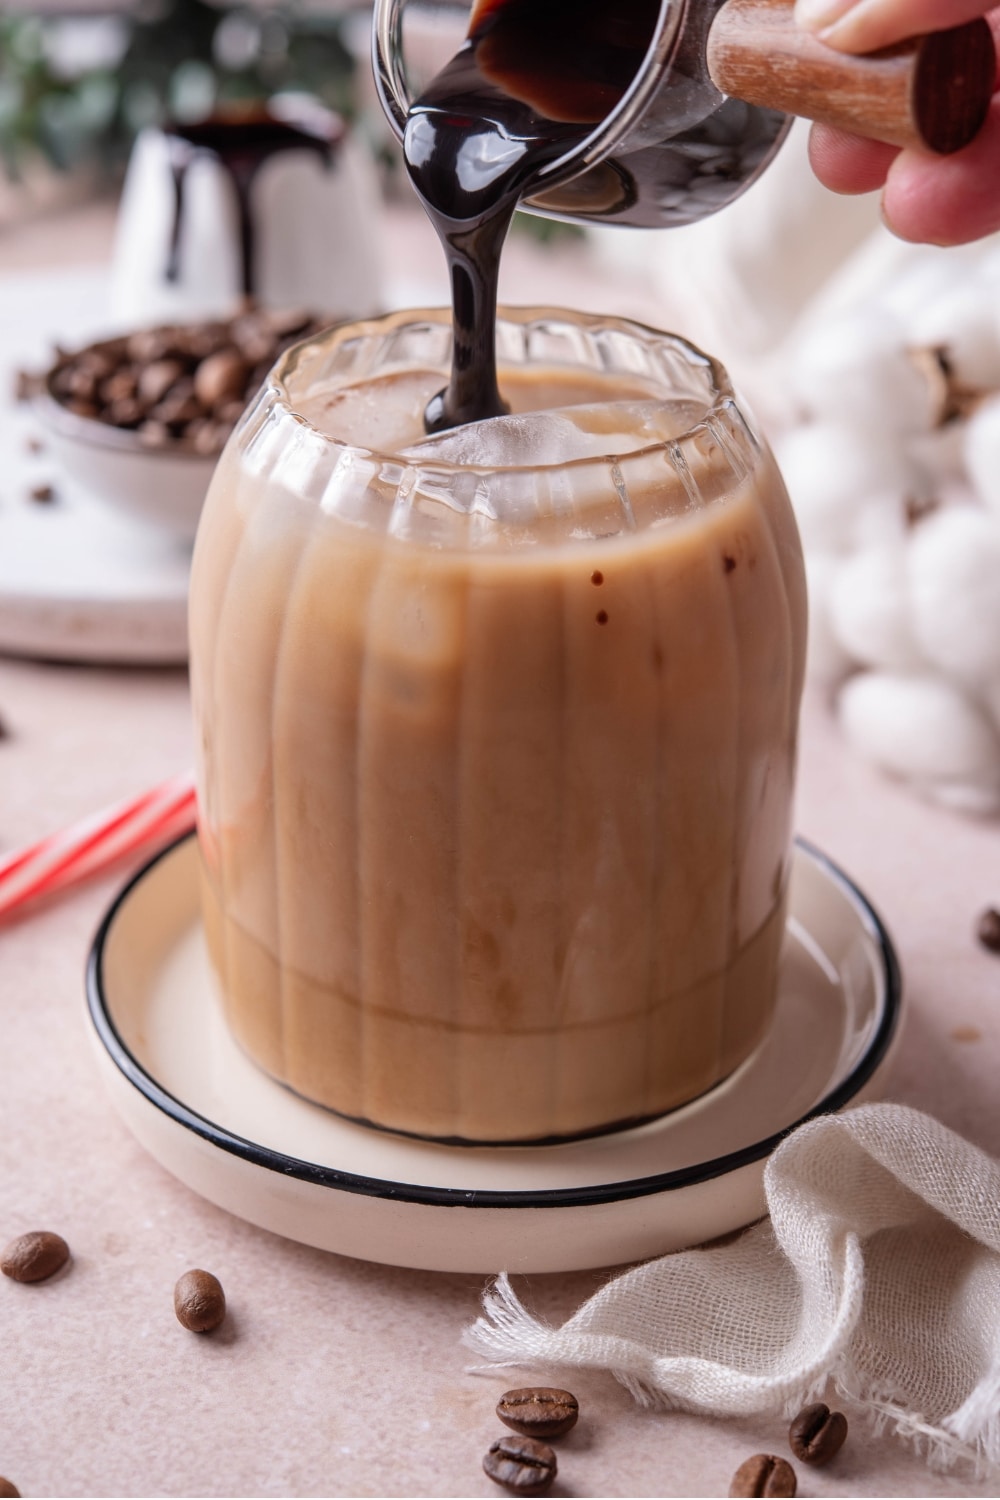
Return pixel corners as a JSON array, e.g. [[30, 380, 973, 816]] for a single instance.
[[792, 306, 942, 434]]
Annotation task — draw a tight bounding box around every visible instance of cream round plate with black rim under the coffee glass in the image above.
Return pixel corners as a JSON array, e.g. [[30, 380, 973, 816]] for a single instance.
[[87, 836, 901, 1272]]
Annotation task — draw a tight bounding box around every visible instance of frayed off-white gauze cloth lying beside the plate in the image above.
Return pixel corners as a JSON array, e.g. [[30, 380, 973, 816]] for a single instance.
[[465, 1104, 1000, 1472]]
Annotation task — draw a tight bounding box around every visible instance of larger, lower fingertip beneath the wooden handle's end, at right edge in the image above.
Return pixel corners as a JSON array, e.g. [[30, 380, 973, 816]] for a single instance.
[[882, 98, 1000, 245]]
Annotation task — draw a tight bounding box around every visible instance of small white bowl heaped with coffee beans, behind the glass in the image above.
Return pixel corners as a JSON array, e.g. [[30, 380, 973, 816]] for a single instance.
[[34, 306, 324, 543]]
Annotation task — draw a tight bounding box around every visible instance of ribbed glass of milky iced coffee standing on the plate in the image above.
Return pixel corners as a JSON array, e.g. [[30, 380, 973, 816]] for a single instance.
[[190, 309, 805, 1143]]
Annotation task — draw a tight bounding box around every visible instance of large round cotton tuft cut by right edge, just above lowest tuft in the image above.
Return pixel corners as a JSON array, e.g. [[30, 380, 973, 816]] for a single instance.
[[907, 506, 1000, 687]]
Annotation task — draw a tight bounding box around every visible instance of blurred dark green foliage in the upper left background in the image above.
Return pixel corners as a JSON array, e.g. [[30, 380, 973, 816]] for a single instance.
[[0, 0, 355, 177]]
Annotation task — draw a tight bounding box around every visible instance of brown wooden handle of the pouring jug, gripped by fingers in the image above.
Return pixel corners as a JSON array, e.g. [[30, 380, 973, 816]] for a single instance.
[[708, 0, 997, 155]]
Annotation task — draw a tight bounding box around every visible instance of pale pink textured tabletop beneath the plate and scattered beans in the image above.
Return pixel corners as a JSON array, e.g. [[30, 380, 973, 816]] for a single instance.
[[0, 202, 1000, 1496]]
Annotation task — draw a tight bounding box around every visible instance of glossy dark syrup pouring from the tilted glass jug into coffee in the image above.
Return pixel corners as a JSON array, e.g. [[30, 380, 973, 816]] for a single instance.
[[403, 0, 660, 432]]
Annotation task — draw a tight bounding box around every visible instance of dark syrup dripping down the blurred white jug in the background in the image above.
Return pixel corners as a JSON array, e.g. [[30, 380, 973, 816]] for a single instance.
[[163, 111, 340, 297]]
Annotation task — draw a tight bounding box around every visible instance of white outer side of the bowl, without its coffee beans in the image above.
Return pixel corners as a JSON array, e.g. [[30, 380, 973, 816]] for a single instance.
[[34, 369, 216, 545]]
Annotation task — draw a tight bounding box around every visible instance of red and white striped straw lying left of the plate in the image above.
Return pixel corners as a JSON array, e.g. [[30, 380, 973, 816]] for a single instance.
[[0, 771, 195, 917]]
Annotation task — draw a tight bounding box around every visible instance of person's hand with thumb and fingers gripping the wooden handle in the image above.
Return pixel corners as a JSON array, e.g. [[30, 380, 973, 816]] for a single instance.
[[795, 0, 1000, 245]]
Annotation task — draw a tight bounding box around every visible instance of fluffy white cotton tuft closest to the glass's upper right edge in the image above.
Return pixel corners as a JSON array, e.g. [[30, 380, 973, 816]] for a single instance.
[[775, 422, 912, 552]]
